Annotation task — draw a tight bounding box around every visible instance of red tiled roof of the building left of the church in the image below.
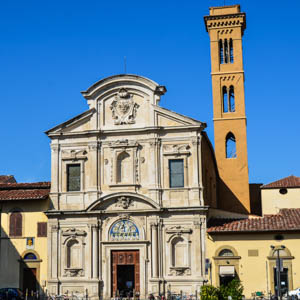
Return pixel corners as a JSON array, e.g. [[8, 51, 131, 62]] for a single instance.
[[0, 182, 50, 201]]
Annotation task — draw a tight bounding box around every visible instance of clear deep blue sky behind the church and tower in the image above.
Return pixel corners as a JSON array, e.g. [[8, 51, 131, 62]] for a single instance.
[[0, 0, 300, 183]]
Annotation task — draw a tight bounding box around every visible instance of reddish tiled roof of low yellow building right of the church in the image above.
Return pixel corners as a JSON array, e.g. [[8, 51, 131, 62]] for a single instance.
[[207, 208, 300, 233]]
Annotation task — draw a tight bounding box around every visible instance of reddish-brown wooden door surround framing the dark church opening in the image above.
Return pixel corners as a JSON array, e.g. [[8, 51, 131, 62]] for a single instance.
[[111, 250, 140, 297]]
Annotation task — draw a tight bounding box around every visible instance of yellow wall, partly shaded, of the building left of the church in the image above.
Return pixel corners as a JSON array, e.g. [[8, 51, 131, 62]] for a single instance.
[[0, 200, 49, 289]]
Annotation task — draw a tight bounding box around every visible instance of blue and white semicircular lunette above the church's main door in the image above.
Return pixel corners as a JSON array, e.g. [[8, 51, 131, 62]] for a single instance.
[[109, 220, 140, 241]]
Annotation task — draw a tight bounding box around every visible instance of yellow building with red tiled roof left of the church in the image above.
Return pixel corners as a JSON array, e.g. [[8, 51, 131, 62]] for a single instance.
[[0, 176, 50, 294]]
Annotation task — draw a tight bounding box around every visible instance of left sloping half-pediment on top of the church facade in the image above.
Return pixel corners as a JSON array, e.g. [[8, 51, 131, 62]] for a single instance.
[[45, 108, 96, 135]]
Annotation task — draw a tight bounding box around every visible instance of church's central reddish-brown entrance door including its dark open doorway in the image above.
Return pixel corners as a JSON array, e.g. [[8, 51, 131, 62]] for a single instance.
[[111, 250, 140, 297]]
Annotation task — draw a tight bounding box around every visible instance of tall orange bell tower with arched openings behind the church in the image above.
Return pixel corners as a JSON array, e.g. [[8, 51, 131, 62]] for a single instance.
[[204, 5, 250, 213]]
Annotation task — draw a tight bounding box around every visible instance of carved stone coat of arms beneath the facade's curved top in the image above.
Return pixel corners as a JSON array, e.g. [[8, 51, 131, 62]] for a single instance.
[[110, 88, 139, 125]]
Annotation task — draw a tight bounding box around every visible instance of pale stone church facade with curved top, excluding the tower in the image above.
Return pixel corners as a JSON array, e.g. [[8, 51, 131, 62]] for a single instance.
[[47, 75, 211, 299]]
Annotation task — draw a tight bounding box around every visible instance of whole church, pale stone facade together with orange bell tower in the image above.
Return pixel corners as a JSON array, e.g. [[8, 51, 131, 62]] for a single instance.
[[47, 5, 255, 298]]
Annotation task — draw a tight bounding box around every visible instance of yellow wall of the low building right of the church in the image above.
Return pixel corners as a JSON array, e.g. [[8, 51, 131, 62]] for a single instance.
[[206, 233, 300, 298]]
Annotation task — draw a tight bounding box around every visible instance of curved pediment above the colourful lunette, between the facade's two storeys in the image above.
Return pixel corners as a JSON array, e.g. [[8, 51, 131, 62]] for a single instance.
[[87, 193, 160, 211]]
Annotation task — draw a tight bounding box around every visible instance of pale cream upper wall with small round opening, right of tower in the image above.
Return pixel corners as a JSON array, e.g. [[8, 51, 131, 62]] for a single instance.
[[261, 188, 300, 215]]
